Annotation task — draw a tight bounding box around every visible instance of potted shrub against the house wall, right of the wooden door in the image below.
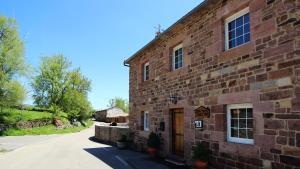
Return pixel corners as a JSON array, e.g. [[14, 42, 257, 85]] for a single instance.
[[192, 144, 209, 169]]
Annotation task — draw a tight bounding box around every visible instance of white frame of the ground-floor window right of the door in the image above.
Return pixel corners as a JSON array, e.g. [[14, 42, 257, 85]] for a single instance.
[[227, 103, 254, 144]]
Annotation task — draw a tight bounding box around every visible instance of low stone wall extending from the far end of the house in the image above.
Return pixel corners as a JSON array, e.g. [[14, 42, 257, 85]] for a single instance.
[[95, 125, 130, 144]]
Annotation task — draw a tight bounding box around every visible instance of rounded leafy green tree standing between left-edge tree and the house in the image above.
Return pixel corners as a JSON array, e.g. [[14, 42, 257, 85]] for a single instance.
[[32, 55, 91, 120]]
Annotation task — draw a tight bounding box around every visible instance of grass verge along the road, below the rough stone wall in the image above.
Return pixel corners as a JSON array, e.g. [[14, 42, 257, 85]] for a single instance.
[[2, 120, 93, 136]]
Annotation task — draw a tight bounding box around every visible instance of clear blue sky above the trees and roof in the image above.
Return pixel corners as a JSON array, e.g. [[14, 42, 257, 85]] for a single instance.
[[0, 0, 201, 109]]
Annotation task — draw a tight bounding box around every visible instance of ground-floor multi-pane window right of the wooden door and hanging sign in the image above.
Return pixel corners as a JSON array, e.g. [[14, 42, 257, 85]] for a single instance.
[[227, 104, 253, 144]]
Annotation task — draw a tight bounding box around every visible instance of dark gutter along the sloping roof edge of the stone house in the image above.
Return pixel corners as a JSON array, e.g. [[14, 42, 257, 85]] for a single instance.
[[124, 0, 211, 64]]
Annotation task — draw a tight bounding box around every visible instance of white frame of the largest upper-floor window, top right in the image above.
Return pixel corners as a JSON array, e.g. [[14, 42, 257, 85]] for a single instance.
[[225, 7, 251, 50]]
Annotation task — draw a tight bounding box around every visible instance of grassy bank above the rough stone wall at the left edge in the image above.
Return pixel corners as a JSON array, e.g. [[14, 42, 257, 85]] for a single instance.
[[0, 108, 53, 124]]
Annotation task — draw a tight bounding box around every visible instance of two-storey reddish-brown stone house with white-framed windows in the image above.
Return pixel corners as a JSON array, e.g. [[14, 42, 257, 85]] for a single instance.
[[124, 0, 300, 169]]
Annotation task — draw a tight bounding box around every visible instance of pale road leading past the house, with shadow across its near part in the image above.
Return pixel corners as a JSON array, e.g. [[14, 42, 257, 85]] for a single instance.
[[0, 123, 132, 169]]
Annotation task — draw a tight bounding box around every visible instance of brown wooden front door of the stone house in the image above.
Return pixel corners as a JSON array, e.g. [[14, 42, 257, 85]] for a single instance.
[[172, 109, 184, 156]]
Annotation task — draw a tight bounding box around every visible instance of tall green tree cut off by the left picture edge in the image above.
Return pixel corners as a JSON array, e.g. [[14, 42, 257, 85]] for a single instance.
[[0, 16, 27, 106]]
